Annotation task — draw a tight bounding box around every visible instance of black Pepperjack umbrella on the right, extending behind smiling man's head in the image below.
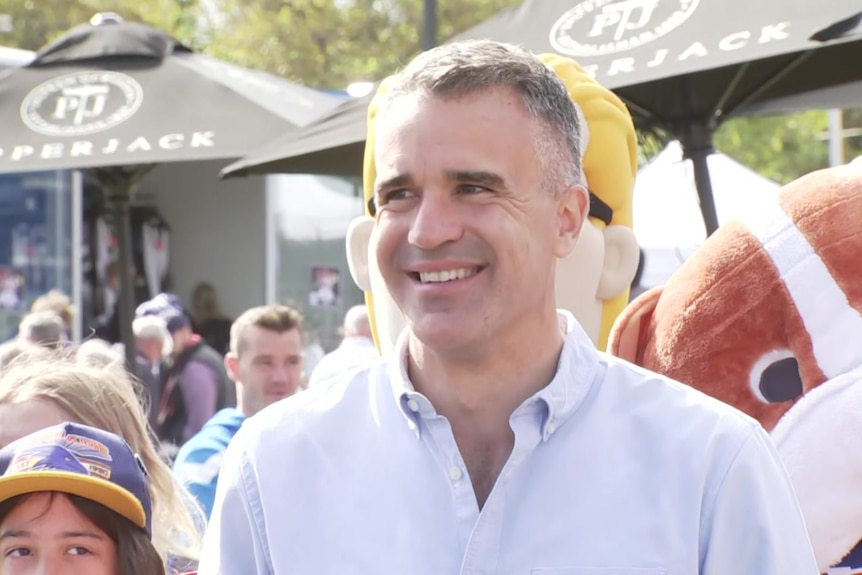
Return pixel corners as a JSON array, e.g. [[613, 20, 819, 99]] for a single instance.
[[222, 0, 862, 238]]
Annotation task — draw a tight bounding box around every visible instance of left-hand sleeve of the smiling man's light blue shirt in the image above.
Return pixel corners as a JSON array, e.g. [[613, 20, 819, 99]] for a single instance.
[[198, 429, 273, 575]]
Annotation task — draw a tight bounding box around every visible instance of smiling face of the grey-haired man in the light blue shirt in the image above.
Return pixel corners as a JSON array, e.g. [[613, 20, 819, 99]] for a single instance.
[[371, 88, 586, 352]]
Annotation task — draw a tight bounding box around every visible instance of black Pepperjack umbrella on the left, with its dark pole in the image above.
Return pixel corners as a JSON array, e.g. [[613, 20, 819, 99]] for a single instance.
[[0, 15, 341, 366]]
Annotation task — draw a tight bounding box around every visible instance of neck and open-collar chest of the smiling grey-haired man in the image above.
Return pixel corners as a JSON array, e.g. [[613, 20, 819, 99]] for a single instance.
[[407, 314, 564, 506]]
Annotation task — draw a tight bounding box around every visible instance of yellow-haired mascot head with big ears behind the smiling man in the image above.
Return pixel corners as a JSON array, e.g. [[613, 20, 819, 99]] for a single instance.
[[347, 54, 640, 353]]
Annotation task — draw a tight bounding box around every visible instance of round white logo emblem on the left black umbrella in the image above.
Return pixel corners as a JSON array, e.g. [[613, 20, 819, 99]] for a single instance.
[[21, 70, 144, 136]]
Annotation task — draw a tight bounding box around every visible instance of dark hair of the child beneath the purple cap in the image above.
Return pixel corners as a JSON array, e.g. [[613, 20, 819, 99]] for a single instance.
[[0, 492, 165, 575]]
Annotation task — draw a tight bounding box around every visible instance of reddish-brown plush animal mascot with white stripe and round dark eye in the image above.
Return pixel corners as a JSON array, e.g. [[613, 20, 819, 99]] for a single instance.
[[609, 161, 862, 575]]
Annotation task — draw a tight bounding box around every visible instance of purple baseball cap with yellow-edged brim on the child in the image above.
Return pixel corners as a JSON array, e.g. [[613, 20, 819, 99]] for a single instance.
[[0, 422, 153, 536]]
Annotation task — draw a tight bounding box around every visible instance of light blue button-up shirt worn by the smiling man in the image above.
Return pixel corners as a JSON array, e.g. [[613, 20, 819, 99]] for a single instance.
[[199, 314, 817, 575]]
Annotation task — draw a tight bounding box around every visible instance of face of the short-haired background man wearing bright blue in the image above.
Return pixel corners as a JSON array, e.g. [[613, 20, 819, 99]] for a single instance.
[[225, 326, 302, 416]]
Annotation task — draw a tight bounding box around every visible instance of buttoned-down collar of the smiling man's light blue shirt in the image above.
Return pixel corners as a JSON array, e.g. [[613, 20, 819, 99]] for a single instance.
[[387, 309, 599, 441]]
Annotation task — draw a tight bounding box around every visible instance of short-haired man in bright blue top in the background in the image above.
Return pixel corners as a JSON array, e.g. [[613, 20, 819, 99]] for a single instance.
[[173, 305, 302, 517]]
